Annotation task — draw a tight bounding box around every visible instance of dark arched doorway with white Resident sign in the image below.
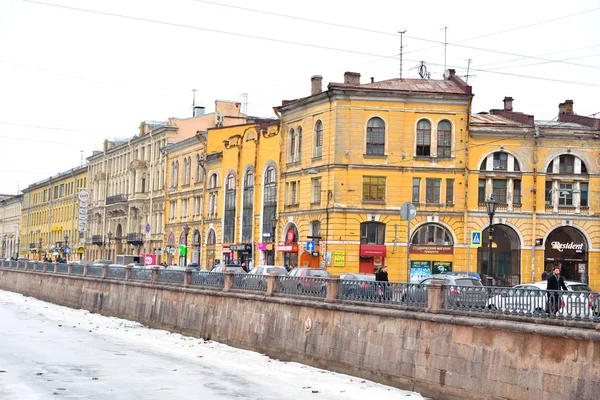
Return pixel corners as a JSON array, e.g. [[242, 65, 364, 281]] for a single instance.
[[544, 226, 588, 283]]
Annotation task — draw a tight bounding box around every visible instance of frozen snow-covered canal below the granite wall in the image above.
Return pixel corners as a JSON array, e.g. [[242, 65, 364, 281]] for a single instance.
[[0, 290, 422, 400]]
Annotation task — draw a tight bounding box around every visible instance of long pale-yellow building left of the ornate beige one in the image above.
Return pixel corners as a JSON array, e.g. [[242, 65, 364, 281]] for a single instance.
[[20, 166, 88, 260]]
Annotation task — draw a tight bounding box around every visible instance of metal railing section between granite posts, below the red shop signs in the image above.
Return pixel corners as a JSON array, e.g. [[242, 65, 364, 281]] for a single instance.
[[338, 280, 427, 307]]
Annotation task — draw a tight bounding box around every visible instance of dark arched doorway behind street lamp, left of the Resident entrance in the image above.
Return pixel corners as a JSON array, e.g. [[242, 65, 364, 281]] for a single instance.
[[477, 224, 521, 286]]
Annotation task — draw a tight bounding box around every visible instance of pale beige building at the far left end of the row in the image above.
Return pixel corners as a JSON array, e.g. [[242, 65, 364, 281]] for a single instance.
[[0, 195, 23, 258]]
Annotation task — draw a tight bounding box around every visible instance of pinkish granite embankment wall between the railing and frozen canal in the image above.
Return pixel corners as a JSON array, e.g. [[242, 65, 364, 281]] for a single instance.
[[0, 270, 600, 400]]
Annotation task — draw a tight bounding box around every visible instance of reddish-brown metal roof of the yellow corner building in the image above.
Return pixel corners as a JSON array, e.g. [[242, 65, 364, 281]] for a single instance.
[[327, 78, 468, 94]]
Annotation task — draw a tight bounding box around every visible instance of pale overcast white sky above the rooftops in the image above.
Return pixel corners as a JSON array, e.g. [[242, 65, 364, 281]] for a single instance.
[[0, 0, 600, 193]]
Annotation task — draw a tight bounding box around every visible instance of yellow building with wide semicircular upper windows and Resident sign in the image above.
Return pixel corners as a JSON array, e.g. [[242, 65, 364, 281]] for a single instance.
[[465, 97, 600, 290]]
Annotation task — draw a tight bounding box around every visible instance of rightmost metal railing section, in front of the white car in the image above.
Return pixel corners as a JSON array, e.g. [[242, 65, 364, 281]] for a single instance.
[[443, 286, 600, 322]]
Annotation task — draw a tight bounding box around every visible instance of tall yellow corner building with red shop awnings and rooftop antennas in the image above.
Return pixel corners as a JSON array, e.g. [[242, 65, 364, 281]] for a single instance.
[[276, 70, 472, 281]]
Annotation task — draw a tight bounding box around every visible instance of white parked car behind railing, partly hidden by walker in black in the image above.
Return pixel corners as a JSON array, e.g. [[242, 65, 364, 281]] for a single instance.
[[488, 281, 600, 317]]
